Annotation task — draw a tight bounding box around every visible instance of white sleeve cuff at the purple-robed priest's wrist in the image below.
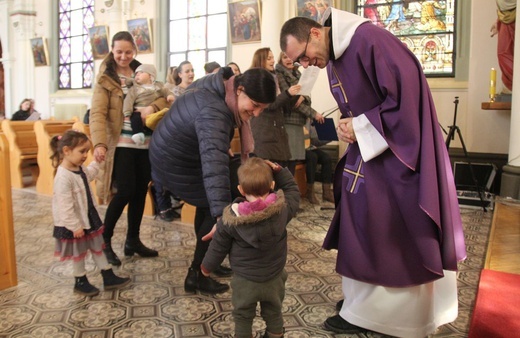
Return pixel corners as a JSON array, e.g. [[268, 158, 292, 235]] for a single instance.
[[352, 114, 388, 162]]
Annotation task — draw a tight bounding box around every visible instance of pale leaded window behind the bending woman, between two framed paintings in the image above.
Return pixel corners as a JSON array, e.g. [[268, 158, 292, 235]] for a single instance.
[[168, 0, 228, 78]]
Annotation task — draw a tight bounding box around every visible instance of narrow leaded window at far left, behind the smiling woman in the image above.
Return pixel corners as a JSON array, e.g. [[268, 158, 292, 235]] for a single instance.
[[58, 0, 95, 89]]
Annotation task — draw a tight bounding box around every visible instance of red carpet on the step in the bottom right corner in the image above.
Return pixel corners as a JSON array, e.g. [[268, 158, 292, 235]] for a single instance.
[[468, 269, 520, 338]]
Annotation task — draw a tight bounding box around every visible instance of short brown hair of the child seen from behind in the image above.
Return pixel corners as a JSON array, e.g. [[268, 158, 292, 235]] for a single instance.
[[238, 157, 273, 196]]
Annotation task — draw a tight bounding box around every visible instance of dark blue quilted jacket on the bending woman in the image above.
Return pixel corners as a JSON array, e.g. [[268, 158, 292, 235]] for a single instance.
[[150, 69, 235, 217]]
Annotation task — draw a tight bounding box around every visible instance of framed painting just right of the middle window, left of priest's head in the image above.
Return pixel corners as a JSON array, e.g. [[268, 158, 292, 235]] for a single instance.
[[228, 0, 262, 43]]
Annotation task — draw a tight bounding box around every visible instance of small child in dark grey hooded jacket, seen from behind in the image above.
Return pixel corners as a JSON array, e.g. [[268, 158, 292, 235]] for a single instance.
[[201, 157, 300, 338]]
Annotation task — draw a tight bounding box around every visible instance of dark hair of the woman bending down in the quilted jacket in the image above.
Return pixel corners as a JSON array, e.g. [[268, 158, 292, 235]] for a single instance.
[[235, 68, 276, 103]]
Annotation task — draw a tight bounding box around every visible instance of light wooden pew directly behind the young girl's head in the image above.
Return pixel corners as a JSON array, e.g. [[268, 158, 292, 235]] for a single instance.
[[34, 120, 75, 195]]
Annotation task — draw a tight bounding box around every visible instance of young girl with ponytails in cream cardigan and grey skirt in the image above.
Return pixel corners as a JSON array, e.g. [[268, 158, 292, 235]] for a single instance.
[[50, 130, 130, 296]]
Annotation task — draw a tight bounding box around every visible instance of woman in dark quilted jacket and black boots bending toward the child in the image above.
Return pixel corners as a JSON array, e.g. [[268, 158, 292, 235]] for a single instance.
[[150, 67, 276, 294]]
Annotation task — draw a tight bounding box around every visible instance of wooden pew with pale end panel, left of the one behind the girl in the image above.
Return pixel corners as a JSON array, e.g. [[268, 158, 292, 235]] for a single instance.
[[2, 120, 38, 188]]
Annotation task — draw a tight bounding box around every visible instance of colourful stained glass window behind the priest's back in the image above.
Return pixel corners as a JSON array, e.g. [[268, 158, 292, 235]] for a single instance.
[[357, 0, 456, 77]]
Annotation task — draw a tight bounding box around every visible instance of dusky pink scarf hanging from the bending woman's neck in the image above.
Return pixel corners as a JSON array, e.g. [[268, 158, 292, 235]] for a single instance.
[[224, 76, 255, 163]]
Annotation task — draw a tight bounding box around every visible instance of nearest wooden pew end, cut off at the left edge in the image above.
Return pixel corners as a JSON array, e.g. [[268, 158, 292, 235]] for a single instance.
[[0, 133, 18, 290]]
